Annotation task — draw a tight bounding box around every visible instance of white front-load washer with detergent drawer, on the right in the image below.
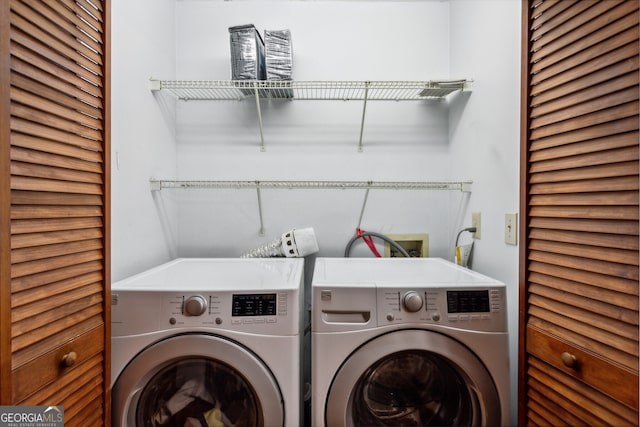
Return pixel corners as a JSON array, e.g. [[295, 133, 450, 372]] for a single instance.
[[311, 258, 510, 427]]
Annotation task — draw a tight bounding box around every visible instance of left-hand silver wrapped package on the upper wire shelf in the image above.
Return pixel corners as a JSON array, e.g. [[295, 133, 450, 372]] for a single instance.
[[229, 24, 266, 95]]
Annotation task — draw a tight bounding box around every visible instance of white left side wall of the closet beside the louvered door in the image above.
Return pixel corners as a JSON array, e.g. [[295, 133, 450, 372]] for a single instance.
[[111, 0, 177, 281]]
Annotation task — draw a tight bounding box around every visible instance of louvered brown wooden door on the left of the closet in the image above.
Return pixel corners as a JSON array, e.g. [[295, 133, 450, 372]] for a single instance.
[[0, 0, 110, 426]]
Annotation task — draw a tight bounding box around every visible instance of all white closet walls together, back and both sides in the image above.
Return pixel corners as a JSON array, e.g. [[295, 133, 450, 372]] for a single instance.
[[112, 0, 520, 421]]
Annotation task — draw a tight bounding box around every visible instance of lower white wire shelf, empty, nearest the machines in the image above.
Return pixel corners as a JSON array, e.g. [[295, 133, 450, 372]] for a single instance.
[[150, 179, 472, 192]]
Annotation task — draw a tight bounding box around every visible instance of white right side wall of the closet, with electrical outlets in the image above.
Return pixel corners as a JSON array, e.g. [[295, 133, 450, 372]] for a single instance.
[[449, 0, 521, 425]]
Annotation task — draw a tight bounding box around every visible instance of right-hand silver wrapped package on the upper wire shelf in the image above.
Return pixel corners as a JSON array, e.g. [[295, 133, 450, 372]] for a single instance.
[[264, 30, 293, 98]]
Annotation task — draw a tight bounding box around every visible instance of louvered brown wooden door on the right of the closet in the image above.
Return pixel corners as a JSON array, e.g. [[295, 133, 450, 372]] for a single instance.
[[519, 0, 640, 426]]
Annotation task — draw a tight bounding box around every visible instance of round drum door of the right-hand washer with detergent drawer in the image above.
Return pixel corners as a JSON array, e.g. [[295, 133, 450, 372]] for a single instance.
[[325, 330, 504, 426]]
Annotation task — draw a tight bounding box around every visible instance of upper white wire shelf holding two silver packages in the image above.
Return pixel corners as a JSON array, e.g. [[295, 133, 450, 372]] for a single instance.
[[151, 79, 472, 101]]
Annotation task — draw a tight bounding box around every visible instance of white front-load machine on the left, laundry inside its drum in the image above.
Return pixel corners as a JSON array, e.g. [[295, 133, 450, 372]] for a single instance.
[[111, 258, 304, 427]]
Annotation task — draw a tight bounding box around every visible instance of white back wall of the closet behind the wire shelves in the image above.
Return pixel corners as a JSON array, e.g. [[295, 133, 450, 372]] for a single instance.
[[172, 1, 468, 258]]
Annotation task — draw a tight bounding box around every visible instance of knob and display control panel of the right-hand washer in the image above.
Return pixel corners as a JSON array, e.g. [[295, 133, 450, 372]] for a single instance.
[[376, 286, 507, 332]]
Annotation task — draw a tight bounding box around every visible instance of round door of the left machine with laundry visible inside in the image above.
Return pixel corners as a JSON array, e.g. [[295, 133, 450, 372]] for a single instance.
[[112, 334, 284, 427]]
